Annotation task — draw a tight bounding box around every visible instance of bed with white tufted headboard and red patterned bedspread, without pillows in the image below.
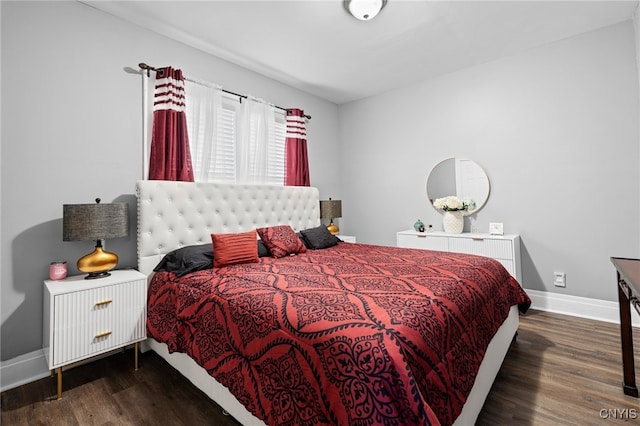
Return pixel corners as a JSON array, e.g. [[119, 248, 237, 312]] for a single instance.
[[136, 181, 530, 425]]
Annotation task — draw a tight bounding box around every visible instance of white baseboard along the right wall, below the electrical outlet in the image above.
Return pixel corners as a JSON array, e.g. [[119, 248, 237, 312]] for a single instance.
[[525, 289, 640, 327]]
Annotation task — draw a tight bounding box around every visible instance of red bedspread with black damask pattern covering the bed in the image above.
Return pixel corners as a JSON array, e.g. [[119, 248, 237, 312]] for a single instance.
[[147, 243, 530, 425]]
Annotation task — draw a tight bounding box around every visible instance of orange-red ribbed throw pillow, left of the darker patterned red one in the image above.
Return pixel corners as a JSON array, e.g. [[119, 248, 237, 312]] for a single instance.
[[211, 229, 259, 268]]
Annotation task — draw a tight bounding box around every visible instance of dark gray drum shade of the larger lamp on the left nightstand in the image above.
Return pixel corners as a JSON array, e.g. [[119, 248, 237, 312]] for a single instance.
[[62, 202, 129, 241]]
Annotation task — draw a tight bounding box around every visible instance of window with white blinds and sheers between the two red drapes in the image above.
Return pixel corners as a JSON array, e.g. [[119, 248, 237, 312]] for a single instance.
[[185, 81, 286, 185]]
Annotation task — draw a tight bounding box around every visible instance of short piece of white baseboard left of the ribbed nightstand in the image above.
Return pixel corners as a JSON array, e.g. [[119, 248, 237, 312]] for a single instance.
[[0, 349, 51, 392]]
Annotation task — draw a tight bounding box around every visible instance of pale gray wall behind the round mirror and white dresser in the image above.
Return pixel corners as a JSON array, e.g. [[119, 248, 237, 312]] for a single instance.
[[340, 21, 640, 300]]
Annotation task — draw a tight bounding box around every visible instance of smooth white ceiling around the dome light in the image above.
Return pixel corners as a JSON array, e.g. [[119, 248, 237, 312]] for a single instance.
[[82, 0, 638, 104]]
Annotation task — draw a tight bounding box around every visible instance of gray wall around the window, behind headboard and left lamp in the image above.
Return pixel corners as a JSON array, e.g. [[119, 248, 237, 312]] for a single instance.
[[0, 1, 341, 360]]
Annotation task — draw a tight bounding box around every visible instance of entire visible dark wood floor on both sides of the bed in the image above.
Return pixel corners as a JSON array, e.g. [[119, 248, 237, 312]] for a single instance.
[[1, 311, 640, 426]]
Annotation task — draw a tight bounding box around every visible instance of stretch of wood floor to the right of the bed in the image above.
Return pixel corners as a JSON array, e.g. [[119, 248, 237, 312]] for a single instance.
[[477, 311, 640, 426]]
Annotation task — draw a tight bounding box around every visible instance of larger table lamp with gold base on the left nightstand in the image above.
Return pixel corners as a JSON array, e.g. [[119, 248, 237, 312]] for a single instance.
[[62, 198, 129, 279]]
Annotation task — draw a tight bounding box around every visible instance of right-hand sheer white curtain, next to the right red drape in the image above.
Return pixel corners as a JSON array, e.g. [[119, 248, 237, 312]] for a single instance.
[[236, 97, 282, 184]]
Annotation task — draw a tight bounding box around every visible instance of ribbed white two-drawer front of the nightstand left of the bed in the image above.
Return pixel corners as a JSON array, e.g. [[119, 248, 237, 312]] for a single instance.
[[52, 280, 146, 365]]
